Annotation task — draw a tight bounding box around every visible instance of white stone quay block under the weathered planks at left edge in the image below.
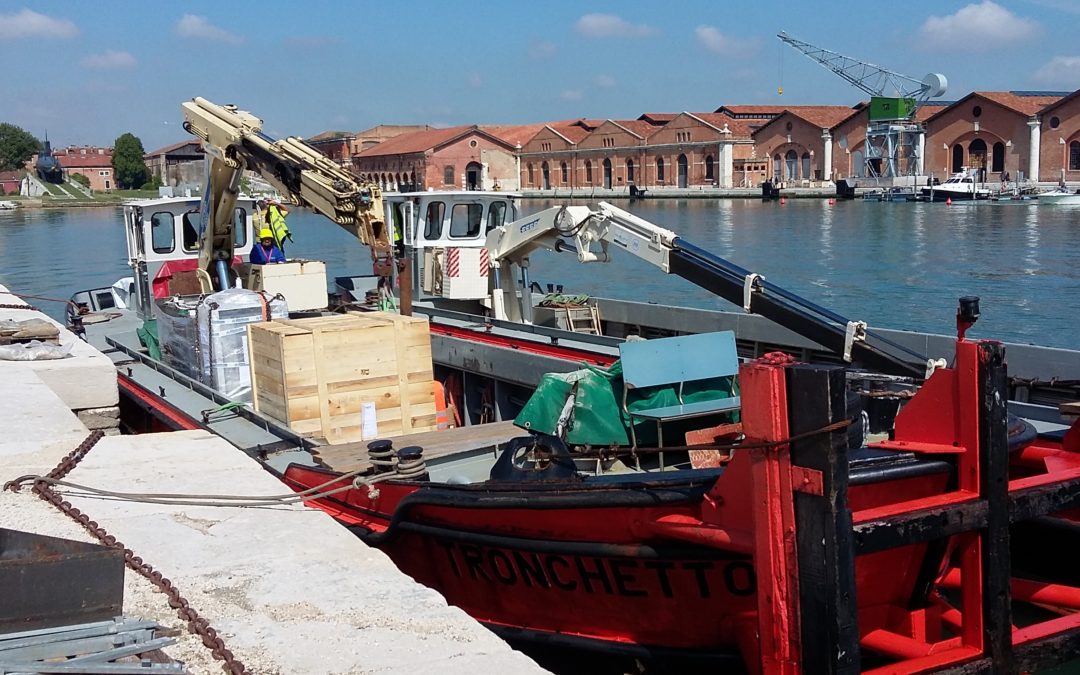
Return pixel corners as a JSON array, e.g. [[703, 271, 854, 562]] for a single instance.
[[0, 285, 120, 410]]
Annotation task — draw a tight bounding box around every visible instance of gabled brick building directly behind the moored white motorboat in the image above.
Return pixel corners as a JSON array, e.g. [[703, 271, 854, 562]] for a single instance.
[[923, 92, 1065, 181]]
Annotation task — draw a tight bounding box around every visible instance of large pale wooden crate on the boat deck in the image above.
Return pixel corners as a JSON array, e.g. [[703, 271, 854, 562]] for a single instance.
[[247, 312, 435, 444]]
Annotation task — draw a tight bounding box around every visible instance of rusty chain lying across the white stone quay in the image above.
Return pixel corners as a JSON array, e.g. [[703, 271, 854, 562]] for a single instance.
[[5, 430, 247, 675]]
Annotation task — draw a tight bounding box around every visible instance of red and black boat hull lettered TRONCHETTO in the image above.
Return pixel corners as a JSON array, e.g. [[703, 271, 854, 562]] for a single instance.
[[285, 458, 948, 656]]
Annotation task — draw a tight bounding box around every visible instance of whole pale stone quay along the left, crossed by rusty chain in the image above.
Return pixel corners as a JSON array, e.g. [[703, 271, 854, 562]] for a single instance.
[[0, 287, 543, 675]]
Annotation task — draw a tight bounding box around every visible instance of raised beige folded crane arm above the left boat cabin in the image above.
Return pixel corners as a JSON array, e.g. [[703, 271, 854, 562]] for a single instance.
[[181, 98, 391, 286]]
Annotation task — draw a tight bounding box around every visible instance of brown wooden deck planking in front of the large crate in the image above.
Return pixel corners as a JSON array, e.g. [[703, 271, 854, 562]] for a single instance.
[[312, 421, 528, 472]]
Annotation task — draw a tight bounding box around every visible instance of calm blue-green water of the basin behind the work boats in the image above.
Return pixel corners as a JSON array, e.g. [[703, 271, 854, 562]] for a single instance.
[[0, 200, 1080, 349]]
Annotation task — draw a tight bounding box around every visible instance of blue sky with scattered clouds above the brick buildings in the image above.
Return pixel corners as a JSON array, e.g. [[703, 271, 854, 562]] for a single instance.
[[0, 0, 1080, 151]]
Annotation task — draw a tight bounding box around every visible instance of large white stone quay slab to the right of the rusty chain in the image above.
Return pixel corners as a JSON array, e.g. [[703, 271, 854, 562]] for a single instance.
[[62, 430, 543, 675]]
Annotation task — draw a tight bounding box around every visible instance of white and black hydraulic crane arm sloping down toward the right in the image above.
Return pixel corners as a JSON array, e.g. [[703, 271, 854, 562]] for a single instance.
[[486, 202, 927, 377]]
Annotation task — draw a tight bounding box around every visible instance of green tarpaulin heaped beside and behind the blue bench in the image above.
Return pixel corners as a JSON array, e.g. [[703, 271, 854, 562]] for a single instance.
[[514, 361, 738, 446]]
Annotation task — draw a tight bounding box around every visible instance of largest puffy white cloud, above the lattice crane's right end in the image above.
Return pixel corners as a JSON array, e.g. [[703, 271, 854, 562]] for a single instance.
[[919, 0, 1039, 53]]
